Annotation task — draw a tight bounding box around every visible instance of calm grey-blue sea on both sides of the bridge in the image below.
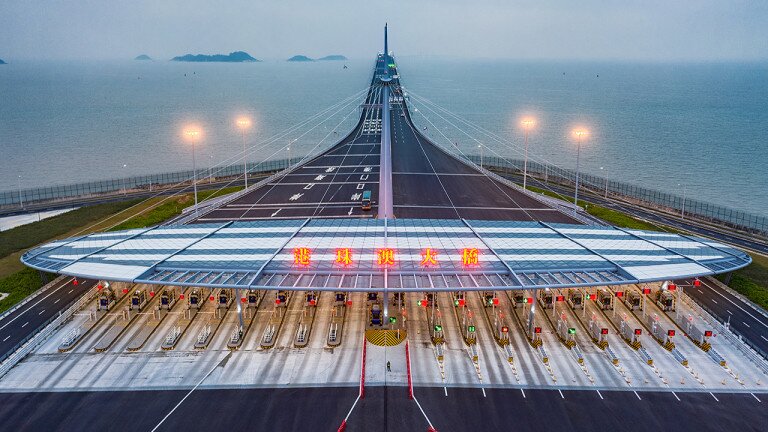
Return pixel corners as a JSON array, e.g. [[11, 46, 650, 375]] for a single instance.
[[0, 57, 768, 215]]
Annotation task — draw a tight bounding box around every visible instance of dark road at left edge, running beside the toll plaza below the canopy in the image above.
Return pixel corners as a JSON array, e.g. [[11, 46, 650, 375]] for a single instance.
[[0, 278, 96, 358]]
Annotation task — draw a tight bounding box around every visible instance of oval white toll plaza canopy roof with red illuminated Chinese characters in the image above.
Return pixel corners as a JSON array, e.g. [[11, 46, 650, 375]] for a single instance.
[[21, 219, 751, 291]]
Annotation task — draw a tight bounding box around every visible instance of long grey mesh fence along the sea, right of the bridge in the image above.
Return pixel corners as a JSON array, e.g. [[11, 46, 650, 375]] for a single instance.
[[467, 155, 768, 236]]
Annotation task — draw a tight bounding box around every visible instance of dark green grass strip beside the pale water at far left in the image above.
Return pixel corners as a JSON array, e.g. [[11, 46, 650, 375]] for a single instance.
[[0, 200, 139, 257]]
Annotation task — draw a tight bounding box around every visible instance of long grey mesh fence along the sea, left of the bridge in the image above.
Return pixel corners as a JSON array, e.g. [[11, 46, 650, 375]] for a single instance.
[[0, 157, 300, 208]]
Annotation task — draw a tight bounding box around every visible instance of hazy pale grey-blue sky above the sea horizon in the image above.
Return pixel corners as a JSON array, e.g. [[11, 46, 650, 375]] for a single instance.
[[0, 0, 768, 61]]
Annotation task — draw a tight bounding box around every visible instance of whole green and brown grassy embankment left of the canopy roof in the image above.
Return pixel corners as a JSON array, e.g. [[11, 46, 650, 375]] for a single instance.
[[0, 186, 242, 313]]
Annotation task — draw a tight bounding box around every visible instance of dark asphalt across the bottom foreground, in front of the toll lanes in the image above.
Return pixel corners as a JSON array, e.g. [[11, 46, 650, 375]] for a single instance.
[[0, 387, 768, 432]]
